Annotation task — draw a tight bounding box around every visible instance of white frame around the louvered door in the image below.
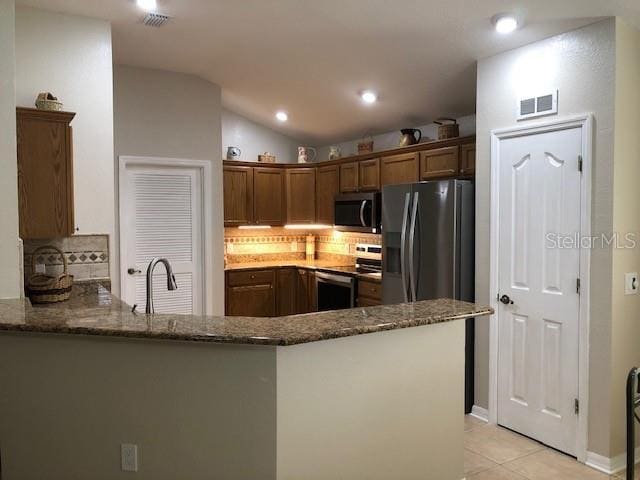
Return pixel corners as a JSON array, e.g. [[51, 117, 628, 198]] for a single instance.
[[118, 155, 213, 315]]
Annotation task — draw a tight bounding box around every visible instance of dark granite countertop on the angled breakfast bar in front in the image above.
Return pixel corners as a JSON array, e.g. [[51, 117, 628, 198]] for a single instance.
[[0, 284, 493, 345]]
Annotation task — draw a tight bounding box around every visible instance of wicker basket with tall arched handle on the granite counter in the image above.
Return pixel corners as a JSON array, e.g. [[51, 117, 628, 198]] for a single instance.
[[27, 245, 73, 303]]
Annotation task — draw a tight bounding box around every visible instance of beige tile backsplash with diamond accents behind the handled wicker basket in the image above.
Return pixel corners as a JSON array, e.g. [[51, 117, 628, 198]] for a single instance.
[[24, 235, 109, 281]]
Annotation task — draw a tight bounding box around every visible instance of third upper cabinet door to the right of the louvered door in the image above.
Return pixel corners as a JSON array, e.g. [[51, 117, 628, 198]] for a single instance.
[[286, 168, 316, 223]]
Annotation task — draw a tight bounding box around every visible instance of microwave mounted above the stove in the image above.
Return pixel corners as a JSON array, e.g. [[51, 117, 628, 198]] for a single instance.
[[334, 192, 382, 233]]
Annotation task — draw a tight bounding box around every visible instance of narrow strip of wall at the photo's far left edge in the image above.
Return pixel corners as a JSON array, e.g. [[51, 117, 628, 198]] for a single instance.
[[0, 0, 22, 298]]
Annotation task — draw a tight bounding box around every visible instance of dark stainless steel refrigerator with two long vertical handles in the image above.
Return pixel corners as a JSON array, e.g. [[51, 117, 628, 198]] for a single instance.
[[382, 180, 475, 413]]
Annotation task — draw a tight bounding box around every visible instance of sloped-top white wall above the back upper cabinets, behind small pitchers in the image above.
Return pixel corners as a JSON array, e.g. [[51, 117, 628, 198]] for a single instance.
[[222, 109, 302, 163]]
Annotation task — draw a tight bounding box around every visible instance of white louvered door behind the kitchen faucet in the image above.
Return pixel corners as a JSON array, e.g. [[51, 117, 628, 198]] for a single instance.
[[120, 162, 204, 314]]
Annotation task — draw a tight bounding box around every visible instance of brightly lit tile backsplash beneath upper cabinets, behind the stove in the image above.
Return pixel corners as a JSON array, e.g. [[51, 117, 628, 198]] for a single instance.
[[224, 228, 381, 263]]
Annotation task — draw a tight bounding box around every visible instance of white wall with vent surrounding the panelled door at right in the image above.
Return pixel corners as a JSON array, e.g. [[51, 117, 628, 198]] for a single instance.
[[476, 19, 615, 456]]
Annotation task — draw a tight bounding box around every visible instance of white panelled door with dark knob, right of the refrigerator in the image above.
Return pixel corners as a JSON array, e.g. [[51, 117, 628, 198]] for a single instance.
[[497, 127, 583, 455]]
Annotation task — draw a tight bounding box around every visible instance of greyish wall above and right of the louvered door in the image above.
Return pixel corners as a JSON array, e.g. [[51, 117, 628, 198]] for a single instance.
[[112, 66, 224, 315]]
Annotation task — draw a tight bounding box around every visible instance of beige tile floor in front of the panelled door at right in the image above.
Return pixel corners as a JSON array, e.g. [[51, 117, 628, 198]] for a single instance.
[[464, 415, 640, 480]]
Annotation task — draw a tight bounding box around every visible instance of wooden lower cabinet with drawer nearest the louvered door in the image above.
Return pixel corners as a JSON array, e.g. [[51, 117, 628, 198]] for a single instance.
[[225, 270, 276, 317]]
